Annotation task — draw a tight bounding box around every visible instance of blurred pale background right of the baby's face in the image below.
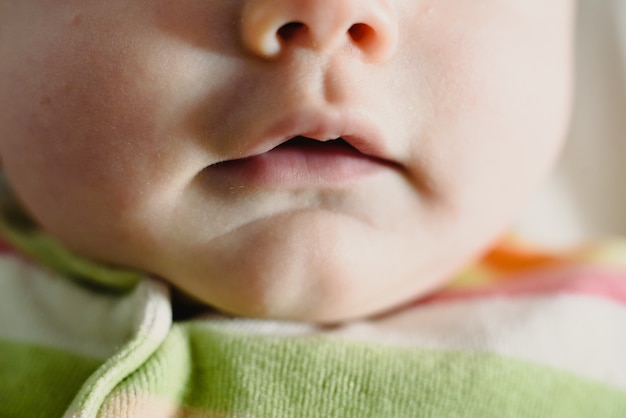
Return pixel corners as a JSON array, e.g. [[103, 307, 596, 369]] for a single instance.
[[517, 0, 626, 247]]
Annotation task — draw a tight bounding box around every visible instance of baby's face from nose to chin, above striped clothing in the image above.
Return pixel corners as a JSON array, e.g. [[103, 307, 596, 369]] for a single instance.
[[0, 0, 573, 321]]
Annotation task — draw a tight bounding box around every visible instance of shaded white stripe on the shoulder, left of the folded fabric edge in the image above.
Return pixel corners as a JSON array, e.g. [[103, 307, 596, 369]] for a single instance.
[[0, 255, 169, 359]]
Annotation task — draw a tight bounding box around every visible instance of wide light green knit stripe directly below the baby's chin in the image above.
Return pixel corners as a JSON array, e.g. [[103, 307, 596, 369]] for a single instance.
[[114, 324, 626, 418]]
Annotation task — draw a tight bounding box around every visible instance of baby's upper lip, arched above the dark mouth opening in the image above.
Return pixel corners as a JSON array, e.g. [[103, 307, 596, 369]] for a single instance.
[[212, 111, 393, 167]]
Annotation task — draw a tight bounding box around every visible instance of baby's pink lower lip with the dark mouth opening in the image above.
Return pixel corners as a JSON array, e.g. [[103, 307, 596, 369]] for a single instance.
[[207, 143, 389, 187]]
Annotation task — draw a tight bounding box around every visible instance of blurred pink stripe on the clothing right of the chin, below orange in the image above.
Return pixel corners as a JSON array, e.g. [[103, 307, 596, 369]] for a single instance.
[[411, 266, 626, 305]]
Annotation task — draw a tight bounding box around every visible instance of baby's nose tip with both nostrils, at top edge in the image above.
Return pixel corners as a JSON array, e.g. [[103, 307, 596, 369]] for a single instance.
[[241, 0, 398, 61]]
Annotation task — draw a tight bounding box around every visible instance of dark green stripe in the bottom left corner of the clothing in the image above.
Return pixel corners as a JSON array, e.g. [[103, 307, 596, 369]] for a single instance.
[[0, 340, 101, 418]]
